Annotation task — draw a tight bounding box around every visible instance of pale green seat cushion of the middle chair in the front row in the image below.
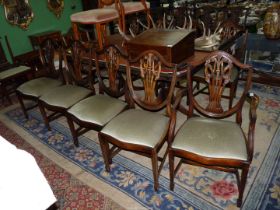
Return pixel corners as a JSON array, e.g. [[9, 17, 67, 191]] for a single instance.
[[68, 95, 127, 127]]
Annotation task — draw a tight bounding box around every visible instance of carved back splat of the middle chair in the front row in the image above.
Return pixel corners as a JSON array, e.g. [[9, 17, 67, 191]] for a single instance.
[[105, 47, 120, 91]]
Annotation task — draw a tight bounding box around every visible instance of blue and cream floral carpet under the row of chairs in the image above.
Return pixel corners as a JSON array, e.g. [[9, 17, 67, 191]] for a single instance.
[[1, 85, 280, 210]]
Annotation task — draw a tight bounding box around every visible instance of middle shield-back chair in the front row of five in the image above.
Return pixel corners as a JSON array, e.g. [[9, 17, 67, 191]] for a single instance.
[[67, 45, 128, 146]]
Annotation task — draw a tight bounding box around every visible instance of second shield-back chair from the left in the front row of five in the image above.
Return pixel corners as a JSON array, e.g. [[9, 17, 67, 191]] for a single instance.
[[39, 40, 95, 130]]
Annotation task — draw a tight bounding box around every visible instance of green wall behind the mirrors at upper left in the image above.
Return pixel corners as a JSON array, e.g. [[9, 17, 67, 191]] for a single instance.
[[0, 0, 82, 61]]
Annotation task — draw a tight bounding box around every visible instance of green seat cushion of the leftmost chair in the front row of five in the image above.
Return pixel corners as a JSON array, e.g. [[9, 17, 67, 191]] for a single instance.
[[17, 77, 62, 97]]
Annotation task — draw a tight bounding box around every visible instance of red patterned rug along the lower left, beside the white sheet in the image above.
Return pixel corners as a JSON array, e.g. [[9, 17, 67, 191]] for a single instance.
[[0, 122, 122, 210]]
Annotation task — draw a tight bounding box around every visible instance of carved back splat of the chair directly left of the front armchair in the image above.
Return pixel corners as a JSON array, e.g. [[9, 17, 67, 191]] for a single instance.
[[140, 53, 161, 104]]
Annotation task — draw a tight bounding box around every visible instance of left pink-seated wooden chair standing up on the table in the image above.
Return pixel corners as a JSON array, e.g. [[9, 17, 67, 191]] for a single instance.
[[71, 0, 122, 52]]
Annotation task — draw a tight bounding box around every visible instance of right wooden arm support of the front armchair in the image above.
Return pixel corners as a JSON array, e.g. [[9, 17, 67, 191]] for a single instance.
[[247, 93, 259, 161]]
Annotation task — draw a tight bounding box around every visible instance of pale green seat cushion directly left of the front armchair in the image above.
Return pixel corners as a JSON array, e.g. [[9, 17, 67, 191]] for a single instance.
[[101, 109, 169, 148]]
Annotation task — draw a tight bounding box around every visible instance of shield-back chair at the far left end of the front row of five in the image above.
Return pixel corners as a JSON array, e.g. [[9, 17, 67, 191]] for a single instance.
[[16, 39, 64, 118]]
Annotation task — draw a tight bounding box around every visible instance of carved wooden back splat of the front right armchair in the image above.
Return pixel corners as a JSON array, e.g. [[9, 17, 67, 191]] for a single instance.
[[204, 55, 233, 113]]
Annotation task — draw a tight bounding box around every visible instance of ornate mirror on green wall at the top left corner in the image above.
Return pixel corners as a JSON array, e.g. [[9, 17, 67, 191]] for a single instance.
[[0, 0, 34, 29]]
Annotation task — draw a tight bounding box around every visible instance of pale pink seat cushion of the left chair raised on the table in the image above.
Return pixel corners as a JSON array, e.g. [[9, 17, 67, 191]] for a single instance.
[[70, 7, 119, 24]]
